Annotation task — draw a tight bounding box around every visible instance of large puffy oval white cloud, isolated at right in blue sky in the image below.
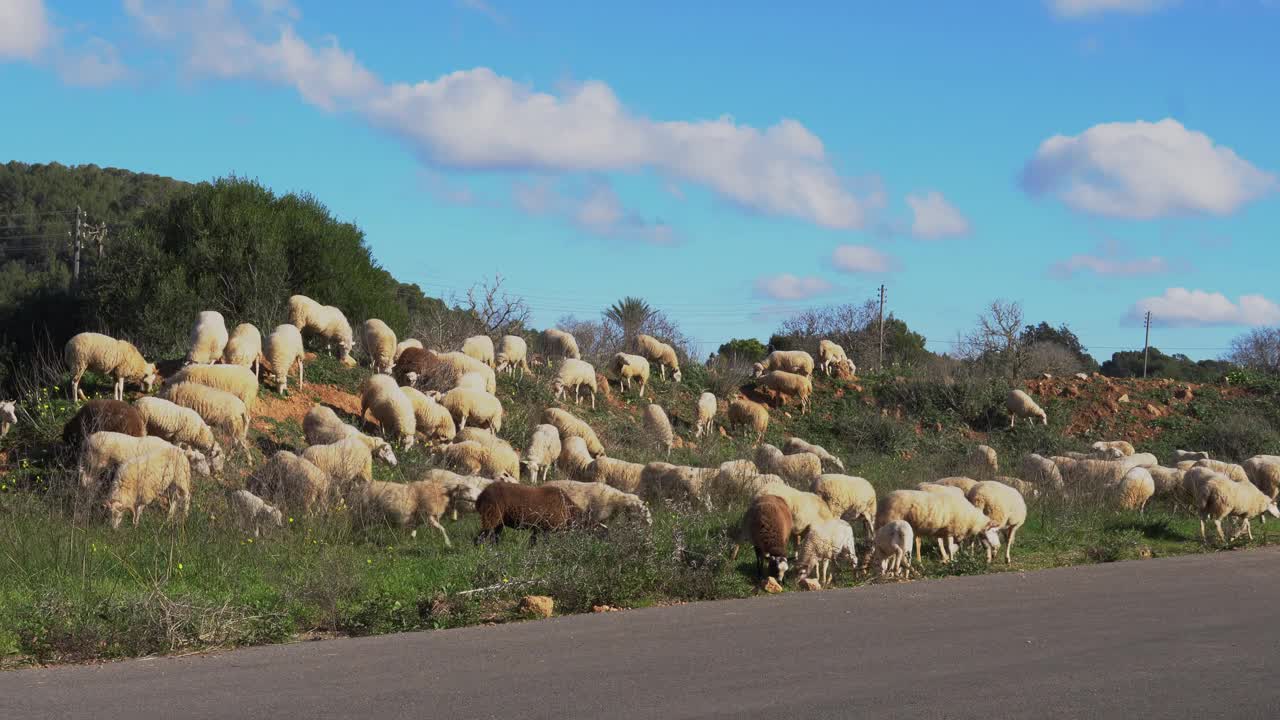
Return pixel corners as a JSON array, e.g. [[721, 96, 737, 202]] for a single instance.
[[1021, 118, 1277, 219]]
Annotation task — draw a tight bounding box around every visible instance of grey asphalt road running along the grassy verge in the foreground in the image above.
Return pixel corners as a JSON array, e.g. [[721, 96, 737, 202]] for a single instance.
[[0, 550, 1280, 720]]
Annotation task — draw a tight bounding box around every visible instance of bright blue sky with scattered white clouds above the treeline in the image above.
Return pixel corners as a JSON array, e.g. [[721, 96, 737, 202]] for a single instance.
[[0, 0, 1280, 359]]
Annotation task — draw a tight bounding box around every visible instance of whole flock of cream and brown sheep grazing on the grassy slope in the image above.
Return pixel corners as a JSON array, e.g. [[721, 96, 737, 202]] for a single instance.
[[0, 295, 1280, 587]]
